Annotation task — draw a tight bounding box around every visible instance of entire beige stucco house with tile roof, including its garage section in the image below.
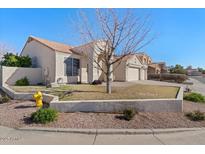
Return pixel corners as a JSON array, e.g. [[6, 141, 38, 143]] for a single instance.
[[21, 36, 147, 83]]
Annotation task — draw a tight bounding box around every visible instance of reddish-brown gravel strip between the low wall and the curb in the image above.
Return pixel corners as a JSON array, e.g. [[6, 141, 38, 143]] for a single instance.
[[0, 100, 205, 128]]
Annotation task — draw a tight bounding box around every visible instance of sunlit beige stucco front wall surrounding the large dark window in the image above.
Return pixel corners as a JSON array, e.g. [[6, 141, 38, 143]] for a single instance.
[[55, 51, 81, 83]]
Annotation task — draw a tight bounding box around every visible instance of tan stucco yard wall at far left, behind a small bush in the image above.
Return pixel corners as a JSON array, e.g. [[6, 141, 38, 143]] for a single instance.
[[2, 66, 42, 85]]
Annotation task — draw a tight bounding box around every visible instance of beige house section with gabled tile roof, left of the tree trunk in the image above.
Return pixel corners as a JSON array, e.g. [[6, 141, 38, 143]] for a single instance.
[[21, 36, 109, 83]]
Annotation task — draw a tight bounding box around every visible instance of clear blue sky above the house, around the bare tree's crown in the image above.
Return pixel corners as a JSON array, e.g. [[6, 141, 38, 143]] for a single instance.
[[0, 9, 205, 68]]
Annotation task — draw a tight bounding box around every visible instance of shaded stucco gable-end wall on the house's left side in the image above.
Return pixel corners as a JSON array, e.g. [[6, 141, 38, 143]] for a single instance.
[[21, 40, 55, 82]]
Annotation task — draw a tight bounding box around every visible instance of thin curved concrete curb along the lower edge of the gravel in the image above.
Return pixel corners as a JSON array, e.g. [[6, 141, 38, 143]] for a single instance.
[[17, 127, 205, 135]]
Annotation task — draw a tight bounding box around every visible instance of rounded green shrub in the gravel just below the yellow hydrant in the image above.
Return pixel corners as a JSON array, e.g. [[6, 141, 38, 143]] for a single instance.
[[31, 108, 58, 124]]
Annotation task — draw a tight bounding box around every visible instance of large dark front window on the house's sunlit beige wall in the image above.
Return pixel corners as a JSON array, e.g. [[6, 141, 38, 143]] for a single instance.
[[64, 58, 80, 76]]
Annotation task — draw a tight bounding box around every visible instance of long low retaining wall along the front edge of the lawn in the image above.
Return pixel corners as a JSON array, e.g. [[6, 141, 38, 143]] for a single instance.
[[50, 87, 183, 112]]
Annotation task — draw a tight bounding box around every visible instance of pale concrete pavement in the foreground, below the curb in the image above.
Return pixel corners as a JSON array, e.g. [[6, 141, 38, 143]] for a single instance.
[[0, 126, 205, 145]]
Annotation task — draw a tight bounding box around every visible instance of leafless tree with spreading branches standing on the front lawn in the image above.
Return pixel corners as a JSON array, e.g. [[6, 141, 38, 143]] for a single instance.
[[77, 9, 153, 93]]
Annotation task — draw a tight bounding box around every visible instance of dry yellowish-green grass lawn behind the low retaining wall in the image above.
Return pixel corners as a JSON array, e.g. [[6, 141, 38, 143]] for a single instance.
[[11, 84, 179, 100]]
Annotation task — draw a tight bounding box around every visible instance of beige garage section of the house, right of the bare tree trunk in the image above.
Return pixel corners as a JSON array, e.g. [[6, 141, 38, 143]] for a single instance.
[[113, 54, 147, 81]]
